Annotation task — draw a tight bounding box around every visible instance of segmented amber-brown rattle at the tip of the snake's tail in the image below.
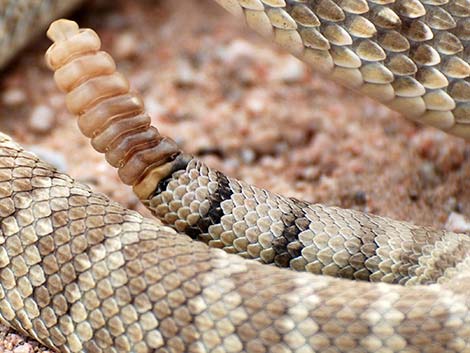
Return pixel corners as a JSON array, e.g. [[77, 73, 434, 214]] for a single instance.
[[46, 20, 188, 198]]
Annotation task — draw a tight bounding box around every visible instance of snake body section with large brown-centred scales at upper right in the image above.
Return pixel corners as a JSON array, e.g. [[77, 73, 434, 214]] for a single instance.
[[216, 0, 470, 139]]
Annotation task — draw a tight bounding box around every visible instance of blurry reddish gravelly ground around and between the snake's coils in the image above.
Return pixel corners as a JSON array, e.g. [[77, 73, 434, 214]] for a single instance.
[[0, 0, 470, 353]]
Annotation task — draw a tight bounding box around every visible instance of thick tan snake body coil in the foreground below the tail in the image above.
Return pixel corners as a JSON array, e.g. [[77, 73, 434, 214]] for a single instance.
[[0, 134, 470, 353]]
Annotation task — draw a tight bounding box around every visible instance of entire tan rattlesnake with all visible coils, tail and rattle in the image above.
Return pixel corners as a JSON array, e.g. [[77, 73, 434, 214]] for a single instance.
[[0, 0, 470, 353]]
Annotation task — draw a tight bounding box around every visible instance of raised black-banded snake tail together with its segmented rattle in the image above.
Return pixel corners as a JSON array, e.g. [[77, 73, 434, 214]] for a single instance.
[[46, 20, 470, 284]]
